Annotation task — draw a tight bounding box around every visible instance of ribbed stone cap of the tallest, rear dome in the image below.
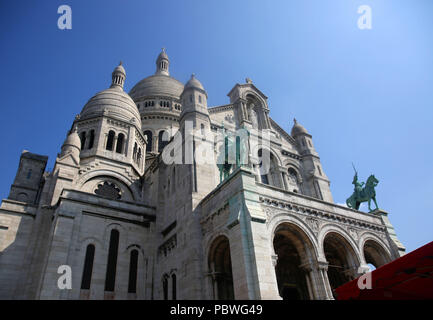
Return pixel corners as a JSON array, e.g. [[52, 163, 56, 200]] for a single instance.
[[129, 74, 183, 100]]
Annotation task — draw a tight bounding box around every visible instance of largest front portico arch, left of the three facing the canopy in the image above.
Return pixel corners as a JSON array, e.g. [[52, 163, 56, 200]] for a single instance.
[[273, 223, 314, 300]]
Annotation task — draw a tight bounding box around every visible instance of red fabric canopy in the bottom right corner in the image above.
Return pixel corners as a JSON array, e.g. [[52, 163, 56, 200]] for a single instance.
[[335, 242, 433, 300]]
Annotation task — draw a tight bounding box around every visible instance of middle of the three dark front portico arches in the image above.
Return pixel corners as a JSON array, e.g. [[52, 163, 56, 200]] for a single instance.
[[323, 232, 359, 290]]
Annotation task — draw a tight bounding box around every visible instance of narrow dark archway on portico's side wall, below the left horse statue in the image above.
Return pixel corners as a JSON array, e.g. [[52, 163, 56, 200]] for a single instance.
[[209, 236, 235, 300]]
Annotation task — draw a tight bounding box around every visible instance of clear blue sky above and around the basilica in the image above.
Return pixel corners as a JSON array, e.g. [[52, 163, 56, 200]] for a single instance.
[[0, 0, 433, 251]]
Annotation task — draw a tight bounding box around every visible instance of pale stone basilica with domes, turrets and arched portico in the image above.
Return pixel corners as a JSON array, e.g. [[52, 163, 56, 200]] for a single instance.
[[0, 49, 405, 300]]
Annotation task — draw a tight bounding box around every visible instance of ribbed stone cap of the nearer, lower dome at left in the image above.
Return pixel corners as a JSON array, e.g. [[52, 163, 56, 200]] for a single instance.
[[80, 88, 141, 128]]
